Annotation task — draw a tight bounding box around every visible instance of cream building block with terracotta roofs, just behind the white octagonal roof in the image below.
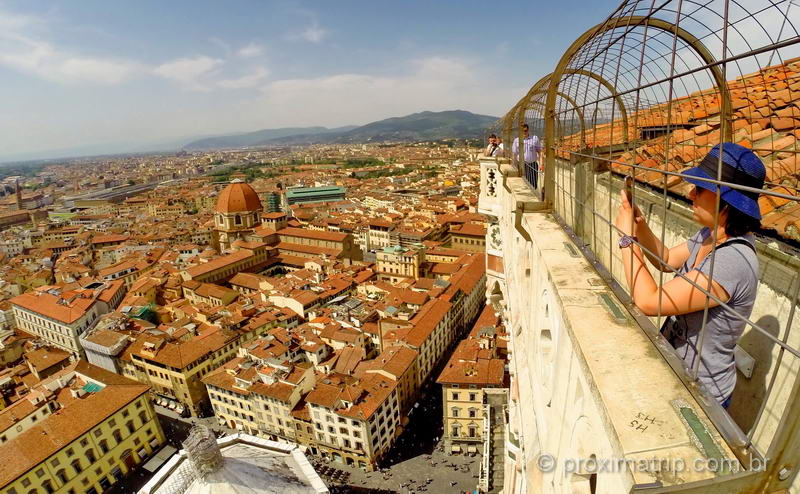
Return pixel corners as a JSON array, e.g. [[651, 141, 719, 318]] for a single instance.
[[203, 343, 400, 470]]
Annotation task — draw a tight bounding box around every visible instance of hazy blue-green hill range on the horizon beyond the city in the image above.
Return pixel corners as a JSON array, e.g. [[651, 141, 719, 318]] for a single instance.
[[184, 110, 497, 149]]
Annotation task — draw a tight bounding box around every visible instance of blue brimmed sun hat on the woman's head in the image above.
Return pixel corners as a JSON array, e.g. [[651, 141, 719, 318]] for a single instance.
[[683, 142, 767, 220]]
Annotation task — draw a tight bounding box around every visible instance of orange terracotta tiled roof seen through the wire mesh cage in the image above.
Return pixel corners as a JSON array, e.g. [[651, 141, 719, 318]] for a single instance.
[[559, 59, 800, 241]]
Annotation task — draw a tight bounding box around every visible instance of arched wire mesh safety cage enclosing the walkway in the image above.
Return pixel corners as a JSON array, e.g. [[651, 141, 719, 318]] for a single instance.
[[498, 0, 800, 470]]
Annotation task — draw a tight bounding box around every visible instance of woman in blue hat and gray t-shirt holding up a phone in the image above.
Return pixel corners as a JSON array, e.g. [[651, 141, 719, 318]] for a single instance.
[[615, 142, 766, 408]]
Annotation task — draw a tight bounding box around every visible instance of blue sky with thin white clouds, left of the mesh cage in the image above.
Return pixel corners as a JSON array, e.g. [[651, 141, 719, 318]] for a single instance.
[[0, 0, 619, 161]]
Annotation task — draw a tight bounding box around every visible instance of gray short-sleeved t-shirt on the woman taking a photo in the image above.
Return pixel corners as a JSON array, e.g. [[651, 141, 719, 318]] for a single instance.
[[665, 228, 758, 403]]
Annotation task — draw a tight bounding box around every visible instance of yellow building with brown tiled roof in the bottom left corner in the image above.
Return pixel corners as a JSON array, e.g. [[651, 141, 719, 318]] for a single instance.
[[0, 361, 164, 494]]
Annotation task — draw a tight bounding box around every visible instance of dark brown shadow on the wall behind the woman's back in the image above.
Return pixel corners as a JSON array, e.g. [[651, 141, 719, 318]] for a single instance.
[[728, 315, 781, 433]]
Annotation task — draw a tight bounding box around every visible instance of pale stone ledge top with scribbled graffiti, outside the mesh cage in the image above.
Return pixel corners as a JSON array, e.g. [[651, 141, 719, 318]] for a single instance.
[[522, 214, 736, 485]]
